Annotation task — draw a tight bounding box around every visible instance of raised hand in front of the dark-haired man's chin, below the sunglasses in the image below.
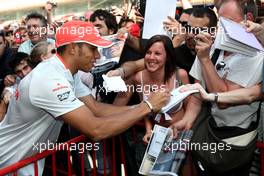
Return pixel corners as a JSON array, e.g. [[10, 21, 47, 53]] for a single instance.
[[194, 32, 213, 61]]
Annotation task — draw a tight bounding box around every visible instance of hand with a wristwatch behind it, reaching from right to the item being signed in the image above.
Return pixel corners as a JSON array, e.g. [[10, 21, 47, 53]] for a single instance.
[[180, 83, 214, 101]]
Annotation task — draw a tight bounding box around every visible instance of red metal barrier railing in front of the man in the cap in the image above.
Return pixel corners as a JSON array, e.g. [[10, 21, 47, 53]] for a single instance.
[[0, 135, 126, 176]]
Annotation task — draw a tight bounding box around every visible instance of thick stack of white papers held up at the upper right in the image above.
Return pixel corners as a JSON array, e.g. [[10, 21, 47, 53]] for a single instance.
[[215, 17, 264, 56]]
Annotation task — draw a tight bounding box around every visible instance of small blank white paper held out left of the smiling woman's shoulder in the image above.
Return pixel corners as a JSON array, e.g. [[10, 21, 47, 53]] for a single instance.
[[102, 75, 127, 92]]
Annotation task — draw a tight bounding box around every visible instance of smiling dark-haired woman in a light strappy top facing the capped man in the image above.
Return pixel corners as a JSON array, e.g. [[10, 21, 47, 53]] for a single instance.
[[114, 35, 192, 143]]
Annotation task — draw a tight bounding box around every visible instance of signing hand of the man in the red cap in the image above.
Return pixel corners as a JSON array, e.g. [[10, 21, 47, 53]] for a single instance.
[[148, 90, 171, 113]]
